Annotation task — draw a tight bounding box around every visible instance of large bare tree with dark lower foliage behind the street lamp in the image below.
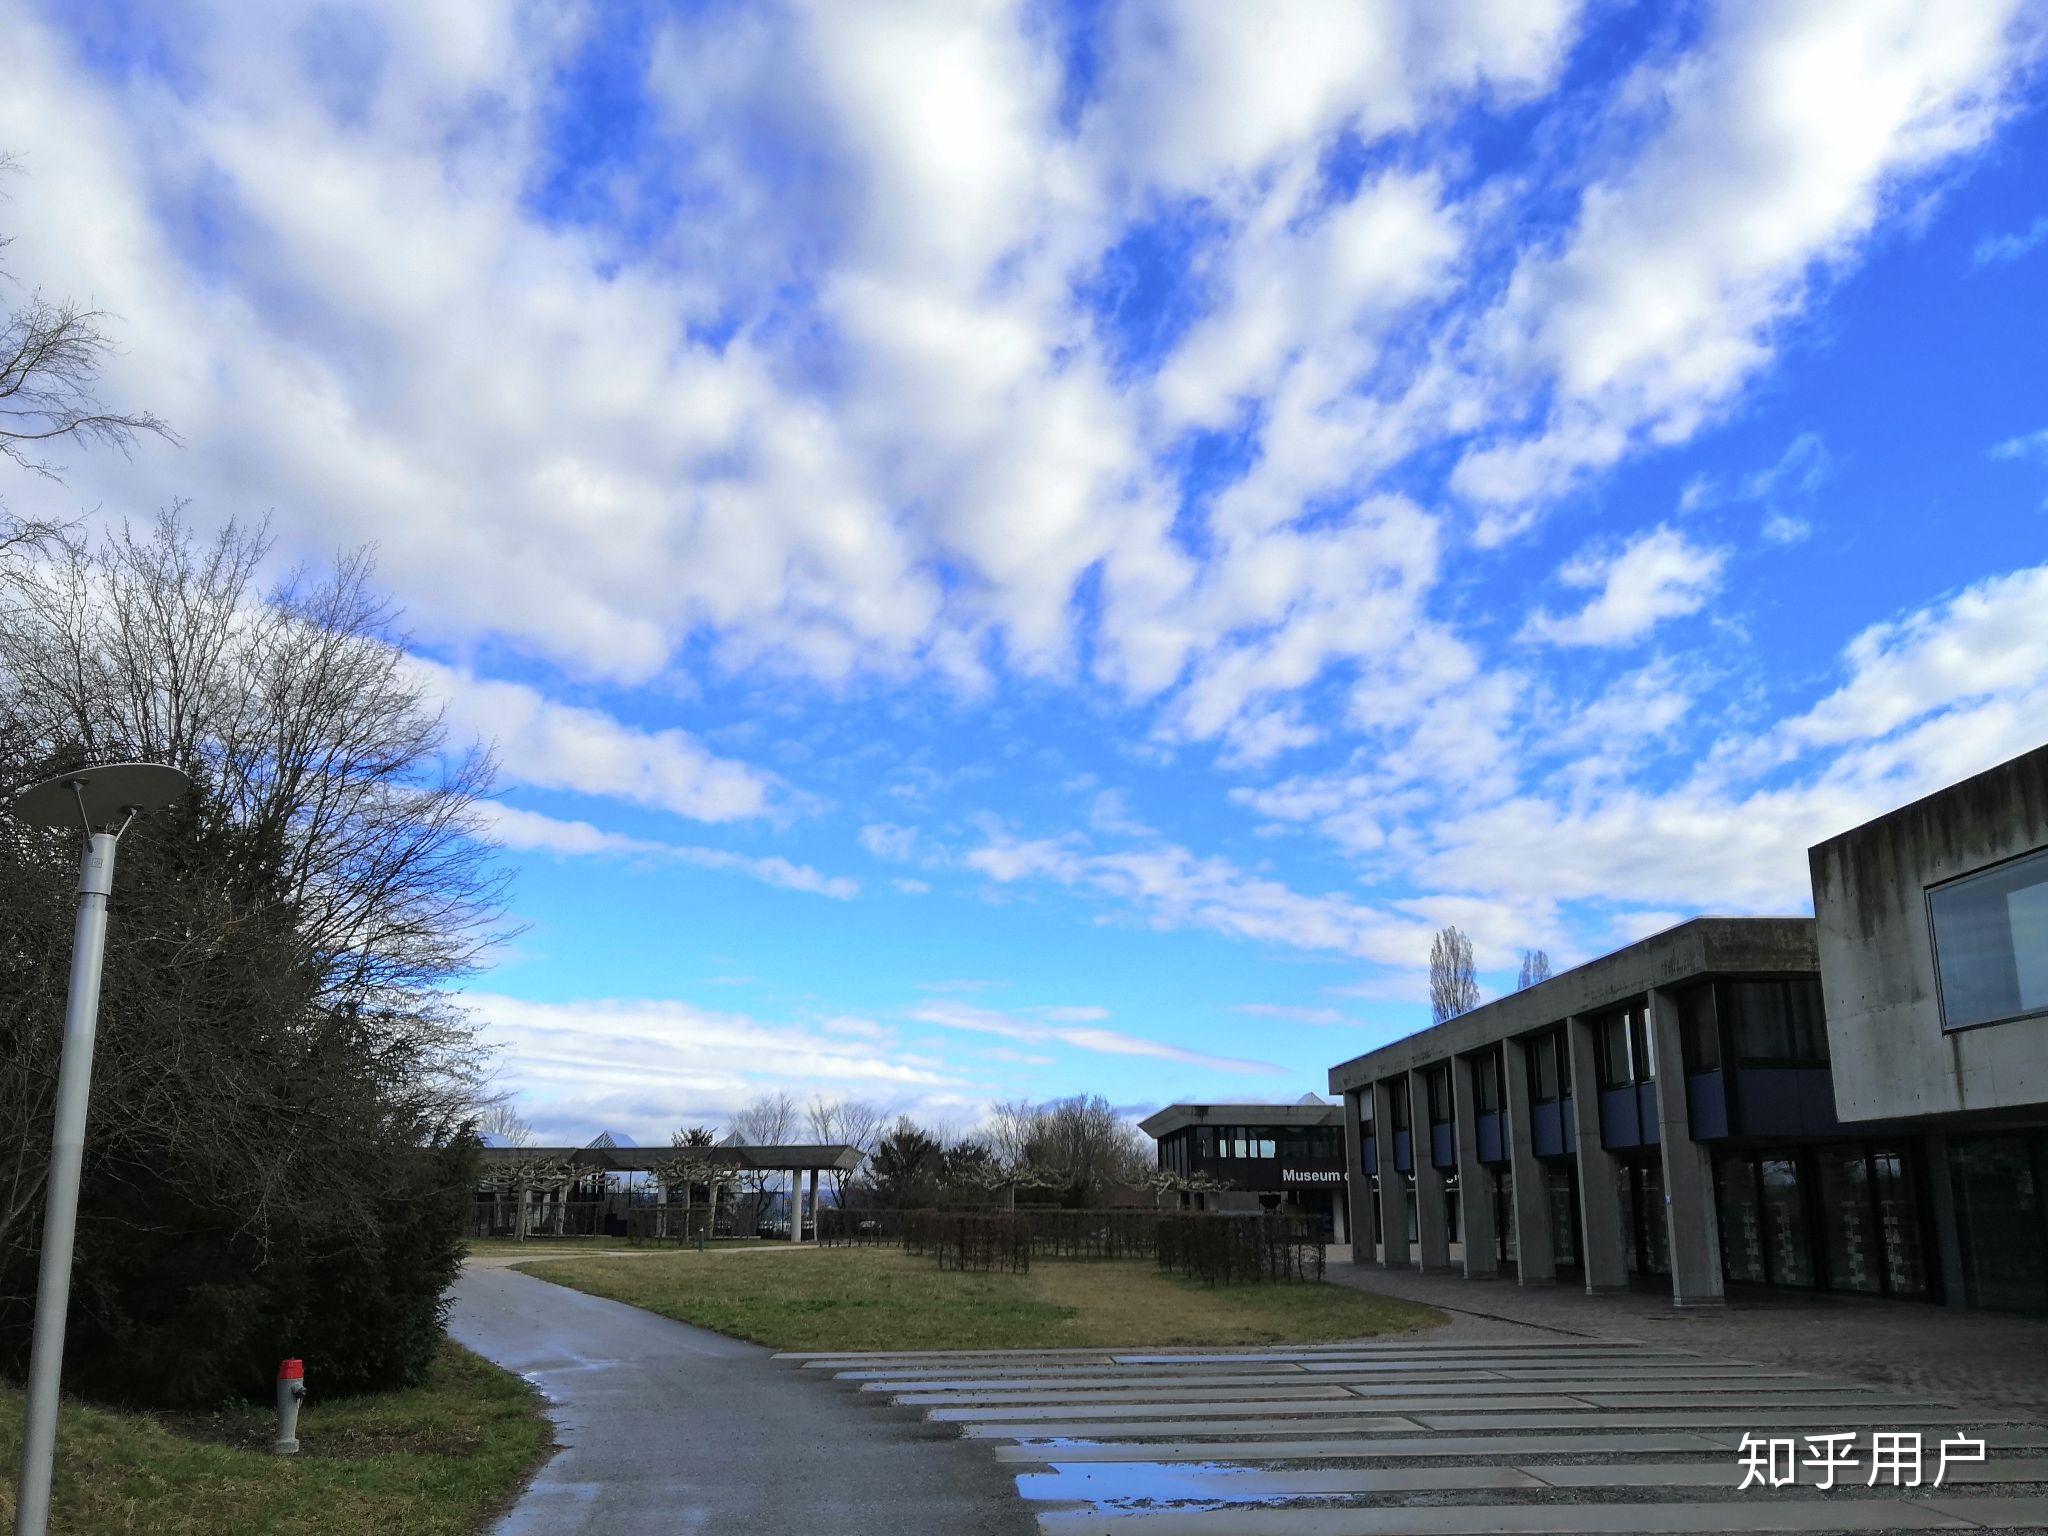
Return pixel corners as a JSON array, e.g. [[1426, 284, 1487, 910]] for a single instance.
[[0, 512, 504, 1397]]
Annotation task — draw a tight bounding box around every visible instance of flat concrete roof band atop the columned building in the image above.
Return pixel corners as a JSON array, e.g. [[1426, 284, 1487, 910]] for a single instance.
[[1329, 918, 1821, 1094]]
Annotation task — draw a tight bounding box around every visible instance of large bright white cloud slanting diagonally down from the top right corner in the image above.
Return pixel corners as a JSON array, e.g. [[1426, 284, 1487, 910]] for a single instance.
[[1456, 0, 2023, 526]]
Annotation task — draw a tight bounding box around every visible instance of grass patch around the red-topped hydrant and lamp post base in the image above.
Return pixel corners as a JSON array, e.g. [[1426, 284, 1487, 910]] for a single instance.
[[0, 1343, 551, 1536]]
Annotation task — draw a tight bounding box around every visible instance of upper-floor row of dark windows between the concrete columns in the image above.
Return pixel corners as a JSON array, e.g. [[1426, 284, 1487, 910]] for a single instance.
[[1358, 977, 1827, 1130]]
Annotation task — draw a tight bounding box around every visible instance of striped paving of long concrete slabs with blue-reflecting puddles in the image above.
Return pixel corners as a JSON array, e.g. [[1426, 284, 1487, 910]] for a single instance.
[[778, 1329, 2048, 1536]]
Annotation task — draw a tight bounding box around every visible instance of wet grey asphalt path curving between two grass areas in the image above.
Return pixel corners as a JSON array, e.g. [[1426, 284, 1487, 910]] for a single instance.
[[449, 1268, 1030, 1536]]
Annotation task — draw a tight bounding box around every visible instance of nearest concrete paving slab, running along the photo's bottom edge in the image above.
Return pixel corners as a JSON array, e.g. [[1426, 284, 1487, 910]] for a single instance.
[[1038, 1497, 1974, 1536]]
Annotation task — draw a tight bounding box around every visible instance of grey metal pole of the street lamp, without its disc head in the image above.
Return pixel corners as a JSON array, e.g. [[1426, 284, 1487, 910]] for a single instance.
[[14, 831, 117, 1536]]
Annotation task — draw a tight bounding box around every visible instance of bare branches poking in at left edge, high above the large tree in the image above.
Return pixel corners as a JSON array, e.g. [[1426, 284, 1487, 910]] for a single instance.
[[0, 156, 178, 493]]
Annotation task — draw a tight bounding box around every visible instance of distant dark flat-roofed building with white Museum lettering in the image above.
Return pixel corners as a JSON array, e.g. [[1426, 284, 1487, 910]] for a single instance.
[[1139, 1096, 1352, 1243]]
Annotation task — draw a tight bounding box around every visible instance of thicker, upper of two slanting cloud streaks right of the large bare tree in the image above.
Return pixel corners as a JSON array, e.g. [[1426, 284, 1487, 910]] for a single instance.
[[412, 657, 774, 821]]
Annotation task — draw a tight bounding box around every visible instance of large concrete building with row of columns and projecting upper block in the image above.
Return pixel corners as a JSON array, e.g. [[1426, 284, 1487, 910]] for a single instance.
[[1329, 748, 2048, 1311]]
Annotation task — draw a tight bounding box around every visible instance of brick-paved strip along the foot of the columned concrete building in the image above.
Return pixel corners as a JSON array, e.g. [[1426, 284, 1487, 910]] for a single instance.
[[1329, 1264, 2048, 1421]]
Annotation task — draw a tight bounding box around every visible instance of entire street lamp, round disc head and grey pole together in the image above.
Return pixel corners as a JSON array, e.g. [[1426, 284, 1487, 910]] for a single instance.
[[14, 762, 190, 1536]]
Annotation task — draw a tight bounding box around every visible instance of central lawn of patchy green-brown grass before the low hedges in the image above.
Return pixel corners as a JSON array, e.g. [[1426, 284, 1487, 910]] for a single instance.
[[516, 1247, 1444, 1350]]
